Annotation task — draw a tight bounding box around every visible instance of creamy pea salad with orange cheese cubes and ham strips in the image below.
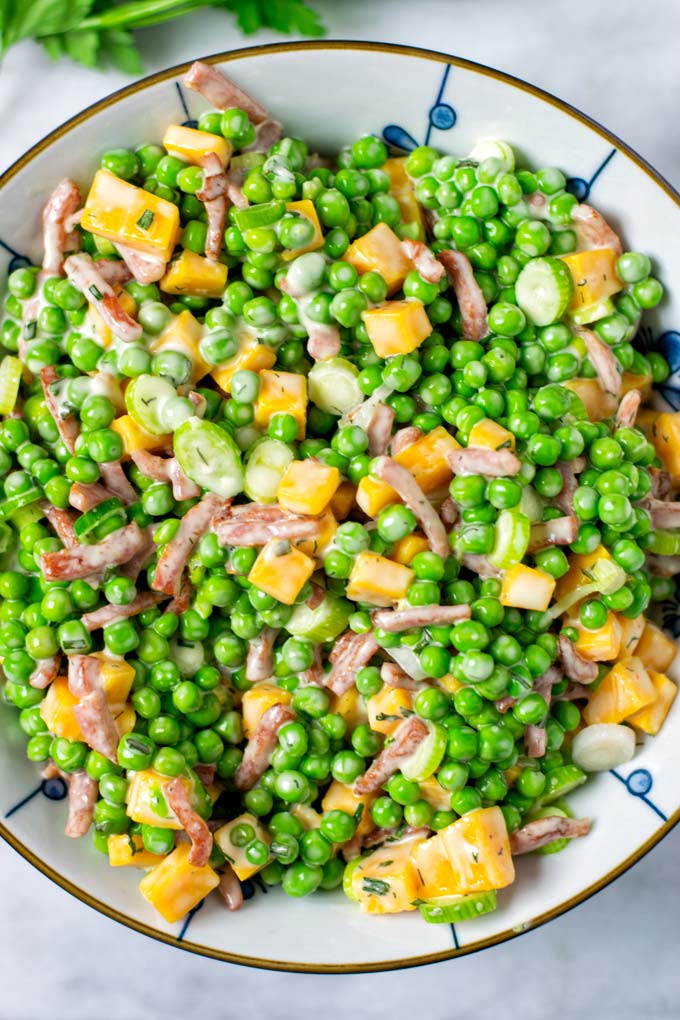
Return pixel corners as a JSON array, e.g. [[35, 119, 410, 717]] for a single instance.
[[0, 63, 680, 923]]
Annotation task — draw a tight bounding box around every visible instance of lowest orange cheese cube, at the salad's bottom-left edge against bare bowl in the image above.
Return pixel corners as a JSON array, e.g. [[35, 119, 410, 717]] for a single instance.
[[140, 843, 219, 924]]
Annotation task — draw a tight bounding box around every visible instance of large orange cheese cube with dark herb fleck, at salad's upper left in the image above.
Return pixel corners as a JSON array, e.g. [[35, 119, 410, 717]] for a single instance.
[[81, 170, 179, 262]]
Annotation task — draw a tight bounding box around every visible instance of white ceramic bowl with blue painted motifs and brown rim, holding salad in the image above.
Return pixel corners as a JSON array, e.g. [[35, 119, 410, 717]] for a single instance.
[[0, 42, 680, 972]]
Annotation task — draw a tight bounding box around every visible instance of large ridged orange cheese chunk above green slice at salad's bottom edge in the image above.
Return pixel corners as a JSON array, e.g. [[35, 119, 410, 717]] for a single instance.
[[413, 808, 515, 900]]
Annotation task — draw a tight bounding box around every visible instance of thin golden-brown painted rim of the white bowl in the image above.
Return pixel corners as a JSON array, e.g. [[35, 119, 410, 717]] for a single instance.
[[0, 39, 680, 974]]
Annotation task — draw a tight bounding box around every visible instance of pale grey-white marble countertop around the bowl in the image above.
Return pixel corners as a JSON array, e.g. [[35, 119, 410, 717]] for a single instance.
[[0, 0, 680, 1020]]
